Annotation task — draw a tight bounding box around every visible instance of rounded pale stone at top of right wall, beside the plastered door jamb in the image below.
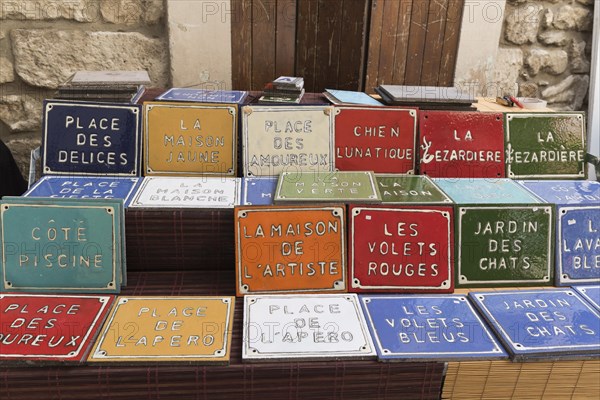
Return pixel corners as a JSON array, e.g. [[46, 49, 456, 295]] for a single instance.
[[504, 3, 543, 44]]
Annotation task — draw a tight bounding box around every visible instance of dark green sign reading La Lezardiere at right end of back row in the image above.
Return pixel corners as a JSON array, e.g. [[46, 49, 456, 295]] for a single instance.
[[505, 112, 587, 179]]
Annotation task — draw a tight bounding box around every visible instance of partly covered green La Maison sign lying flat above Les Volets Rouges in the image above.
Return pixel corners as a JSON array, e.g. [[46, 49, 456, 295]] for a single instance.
[[375, 174, 452, 204]]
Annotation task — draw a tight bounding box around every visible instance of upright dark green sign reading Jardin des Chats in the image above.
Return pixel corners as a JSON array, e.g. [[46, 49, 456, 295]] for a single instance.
[[455, 204, 554, 287]]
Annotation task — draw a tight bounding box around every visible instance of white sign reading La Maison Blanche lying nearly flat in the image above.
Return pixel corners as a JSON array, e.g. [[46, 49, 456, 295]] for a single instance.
[[129, 177, 240, 208]]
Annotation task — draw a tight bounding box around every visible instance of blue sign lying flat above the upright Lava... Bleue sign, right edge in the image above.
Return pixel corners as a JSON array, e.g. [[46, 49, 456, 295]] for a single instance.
[[519, 181, 600, 205]]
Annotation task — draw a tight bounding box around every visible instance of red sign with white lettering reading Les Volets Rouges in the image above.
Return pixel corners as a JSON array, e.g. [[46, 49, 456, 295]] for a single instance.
[[348, 206, 454, 293]]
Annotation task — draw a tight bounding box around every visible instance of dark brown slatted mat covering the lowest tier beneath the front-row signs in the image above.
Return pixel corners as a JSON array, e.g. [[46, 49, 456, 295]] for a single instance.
[[0, 267, 445, 400]]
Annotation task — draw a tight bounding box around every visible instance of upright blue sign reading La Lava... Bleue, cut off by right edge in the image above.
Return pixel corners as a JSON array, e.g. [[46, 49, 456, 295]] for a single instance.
[[556, 206, 600, 285]]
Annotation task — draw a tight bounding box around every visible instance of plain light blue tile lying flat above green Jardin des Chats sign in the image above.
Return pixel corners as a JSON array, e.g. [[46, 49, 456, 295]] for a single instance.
[[433, 178, 540, 204]]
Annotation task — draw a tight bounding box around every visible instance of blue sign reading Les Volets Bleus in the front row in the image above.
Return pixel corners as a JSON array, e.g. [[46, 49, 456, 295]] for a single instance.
[[360, 295, 507, 361]]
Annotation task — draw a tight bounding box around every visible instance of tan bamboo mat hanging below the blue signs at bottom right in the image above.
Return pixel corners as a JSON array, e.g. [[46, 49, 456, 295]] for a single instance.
[[442, 360, 600, 400]]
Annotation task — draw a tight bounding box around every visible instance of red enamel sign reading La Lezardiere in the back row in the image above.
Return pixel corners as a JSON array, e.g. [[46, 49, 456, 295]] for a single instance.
[[419, 111, 505, 178]]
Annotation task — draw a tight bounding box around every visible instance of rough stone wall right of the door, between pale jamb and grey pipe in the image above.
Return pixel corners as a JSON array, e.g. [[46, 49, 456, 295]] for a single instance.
[[496, 0, 594, 111]]
